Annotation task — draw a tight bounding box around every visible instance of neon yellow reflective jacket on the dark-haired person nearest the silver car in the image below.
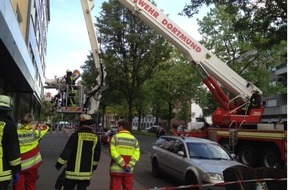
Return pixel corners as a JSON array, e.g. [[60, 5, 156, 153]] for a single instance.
[[110, 130, 140, 175]]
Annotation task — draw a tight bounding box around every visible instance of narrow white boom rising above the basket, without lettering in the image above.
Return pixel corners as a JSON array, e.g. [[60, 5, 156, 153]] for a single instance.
[[81, 0, 107, 114]]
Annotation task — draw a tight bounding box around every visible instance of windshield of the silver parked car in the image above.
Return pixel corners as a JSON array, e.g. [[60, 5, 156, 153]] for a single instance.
[[187, 142, 232, 160]]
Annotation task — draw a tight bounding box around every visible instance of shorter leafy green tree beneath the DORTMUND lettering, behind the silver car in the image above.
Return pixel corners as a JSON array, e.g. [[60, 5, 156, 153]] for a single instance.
[[147, 49, 205, 130]]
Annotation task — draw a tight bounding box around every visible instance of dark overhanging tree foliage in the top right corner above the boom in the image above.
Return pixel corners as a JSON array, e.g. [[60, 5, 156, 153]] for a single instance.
[[181, 0, 287, 50]]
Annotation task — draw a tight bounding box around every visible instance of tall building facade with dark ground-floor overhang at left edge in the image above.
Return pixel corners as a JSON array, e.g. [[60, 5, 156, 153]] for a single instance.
[[0, 0, 50, 121]]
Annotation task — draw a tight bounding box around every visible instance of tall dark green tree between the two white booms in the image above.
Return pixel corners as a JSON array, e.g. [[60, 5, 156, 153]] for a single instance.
[[96, 0, 171, 127]]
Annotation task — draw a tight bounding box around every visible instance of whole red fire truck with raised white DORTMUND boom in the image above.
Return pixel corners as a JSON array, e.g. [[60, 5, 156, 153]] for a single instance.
[[119, 0, 287, 167]]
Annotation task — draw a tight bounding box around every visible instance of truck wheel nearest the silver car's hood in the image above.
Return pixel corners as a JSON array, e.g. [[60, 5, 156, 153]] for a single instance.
[[239, 145, 259, 167]]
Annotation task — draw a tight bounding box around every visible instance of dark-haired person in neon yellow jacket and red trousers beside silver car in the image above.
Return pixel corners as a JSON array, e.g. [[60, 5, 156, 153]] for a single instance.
[[109, 120, 140, 190]]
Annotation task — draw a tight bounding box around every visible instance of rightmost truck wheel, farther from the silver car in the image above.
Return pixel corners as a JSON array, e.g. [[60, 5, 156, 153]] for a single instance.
[[262, 147, 282, 168]]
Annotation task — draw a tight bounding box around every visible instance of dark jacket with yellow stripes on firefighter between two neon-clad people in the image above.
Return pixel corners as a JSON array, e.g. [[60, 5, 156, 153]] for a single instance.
[[56, 127, 101, 180]]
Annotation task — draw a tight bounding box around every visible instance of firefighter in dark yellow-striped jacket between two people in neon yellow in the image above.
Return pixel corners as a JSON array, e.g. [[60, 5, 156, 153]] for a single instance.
[[55, 114, 101, 190]]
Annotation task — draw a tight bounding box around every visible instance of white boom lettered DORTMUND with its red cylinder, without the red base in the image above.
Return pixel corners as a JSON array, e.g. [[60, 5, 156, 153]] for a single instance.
[[119, 0, 263, 127]]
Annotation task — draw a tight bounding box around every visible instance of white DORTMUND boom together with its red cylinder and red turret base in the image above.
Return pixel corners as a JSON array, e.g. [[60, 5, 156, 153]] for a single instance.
[[119, 0, 263, 127]]
